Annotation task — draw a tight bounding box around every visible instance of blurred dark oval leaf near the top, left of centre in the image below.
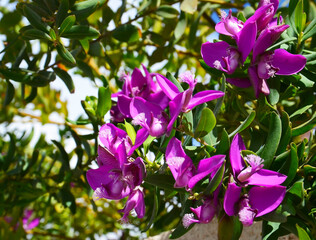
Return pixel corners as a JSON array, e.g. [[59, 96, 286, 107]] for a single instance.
[[113, 24, 140, 43]]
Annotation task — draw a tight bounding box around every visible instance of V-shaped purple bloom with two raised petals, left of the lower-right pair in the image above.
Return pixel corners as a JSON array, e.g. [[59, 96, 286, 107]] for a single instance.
[[166, 137, 225, 190]]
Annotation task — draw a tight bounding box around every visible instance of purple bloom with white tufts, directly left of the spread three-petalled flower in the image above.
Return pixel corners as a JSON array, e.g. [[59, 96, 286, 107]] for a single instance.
[[130, 97, 169, 137]]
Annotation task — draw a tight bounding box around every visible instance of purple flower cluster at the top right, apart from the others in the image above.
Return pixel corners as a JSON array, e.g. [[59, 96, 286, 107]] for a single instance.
[[201, 0, 306, 98]]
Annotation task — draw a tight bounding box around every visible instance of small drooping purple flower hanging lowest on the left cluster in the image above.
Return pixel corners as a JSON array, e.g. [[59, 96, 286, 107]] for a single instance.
[[119, 188, 145, 223]]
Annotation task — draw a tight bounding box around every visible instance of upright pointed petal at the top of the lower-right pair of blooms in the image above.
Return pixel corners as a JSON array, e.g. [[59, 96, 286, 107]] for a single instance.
[[229, 133, 246, 177]]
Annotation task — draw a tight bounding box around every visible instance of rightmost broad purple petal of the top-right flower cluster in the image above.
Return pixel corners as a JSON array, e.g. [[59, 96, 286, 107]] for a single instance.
[[272, 49, 306, 75]]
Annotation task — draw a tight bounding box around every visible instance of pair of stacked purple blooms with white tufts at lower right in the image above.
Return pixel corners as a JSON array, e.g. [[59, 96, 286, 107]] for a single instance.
[[224, 134, 286, 226]]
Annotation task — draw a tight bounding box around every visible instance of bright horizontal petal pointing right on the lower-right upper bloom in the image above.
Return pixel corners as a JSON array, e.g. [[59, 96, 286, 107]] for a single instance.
[[247, 169, 287, 186]]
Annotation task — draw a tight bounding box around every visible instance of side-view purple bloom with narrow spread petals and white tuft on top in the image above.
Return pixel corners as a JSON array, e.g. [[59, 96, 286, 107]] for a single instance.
[[157, 71, 225, 133]]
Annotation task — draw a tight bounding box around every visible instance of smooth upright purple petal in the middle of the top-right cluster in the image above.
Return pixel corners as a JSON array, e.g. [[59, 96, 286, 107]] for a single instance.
[[237, 22, 257, 63]]
